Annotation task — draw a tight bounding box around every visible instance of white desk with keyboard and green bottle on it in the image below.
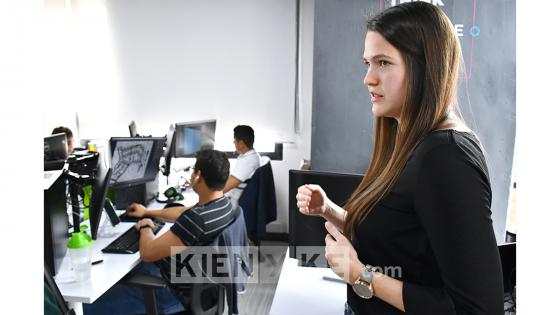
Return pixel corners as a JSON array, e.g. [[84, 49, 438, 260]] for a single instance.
[[55, 196, 198, 314]]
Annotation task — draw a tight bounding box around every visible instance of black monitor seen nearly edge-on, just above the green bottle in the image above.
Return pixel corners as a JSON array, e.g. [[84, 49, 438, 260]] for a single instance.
[[89, 164, 119, 240]]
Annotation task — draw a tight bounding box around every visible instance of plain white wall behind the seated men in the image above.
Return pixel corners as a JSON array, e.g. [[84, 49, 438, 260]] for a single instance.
[[44, 0, 314, 232]]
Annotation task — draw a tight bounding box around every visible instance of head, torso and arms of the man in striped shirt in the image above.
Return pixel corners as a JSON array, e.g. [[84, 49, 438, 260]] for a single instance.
[[127, 150, 235, 262]]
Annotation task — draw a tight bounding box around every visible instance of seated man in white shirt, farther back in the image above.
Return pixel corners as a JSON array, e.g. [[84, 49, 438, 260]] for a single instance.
[[224, 125, 261, 209]]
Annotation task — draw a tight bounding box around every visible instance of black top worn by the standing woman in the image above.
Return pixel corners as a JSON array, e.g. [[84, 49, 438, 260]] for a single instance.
[[347, 130, 504, 315]]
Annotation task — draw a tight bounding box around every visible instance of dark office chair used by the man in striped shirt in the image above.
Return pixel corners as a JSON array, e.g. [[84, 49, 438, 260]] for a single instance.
[[121, 208, 252, 315]]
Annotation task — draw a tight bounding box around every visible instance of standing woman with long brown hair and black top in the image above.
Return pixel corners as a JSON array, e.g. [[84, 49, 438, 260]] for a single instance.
[[296, 2, 503, 314]]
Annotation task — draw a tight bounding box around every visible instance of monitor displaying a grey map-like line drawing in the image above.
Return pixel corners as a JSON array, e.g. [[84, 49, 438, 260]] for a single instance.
[[109, 137, 165, 188]]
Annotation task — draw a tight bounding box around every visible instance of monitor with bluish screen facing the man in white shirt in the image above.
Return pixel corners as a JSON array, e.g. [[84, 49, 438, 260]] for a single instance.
[[174, 120, 216, 157]]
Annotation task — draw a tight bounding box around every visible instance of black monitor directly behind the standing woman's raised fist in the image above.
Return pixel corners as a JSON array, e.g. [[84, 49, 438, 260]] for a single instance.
[[288, 170, 363, 266]]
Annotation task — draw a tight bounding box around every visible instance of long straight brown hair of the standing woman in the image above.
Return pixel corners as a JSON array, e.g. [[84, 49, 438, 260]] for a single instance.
[[344, 2, 462, 237]]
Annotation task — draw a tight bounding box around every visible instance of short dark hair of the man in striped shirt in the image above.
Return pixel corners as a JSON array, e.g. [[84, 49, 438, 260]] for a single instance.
[[194, 150, 229, 190]]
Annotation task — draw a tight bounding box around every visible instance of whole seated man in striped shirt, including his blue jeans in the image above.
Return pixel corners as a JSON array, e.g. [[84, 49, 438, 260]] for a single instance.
[[84, 150, 235, 314]]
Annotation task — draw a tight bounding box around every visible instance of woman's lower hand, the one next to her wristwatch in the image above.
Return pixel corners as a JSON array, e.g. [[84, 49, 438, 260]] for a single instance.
[[325, 221, 364, 284]]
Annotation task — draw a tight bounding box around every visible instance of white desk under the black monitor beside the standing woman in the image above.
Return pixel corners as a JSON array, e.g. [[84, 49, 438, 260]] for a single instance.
[[270, 249, 346, 315]]
